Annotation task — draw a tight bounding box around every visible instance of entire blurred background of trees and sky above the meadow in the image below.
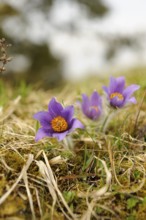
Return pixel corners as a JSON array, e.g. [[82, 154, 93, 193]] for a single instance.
[[0, 0, 146, 88]]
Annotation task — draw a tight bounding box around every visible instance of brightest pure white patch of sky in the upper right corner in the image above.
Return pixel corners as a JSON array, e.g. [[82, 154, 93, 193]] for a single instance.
[[103, 0, 146, 33]]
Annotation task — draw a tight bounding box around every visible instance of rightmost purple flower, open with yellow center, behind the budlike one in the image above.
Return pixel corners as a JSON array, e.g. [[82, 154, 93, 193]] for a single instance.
[[103, 76, 140, 108]]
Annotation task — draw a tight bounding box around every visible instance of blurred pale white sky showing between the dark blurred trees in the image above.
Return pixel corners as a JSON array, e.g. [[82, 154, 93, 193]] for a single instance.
[[51, 0, 146, 79]]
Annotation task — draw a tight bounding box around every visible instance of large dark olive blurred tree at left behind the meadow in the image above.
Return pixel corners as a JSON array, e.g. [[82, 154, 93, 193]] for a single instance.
[[0, 1, 62, 87]]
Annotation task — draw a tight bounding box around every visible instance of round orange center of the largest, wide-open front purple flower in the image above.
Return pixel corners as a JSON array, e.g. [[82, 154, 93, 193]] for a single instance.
[[51, 116, 68, 132]]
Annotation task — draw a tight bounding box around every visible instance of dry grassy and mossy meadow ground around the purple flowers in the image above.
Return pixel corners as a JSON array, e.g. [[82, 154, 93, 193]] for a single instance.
[[0, 69, 146, 220]]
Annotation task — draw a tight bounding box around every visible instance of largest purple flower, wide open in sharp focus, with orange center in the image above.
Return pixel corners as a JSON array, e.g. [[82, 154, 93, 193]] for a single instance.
[[34, 98, 84, 141]]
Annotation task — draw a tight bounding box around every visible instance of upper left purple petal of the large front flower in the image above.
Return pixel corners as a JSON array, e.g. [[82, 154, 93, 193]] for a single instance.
[[33, 111, 52, 128]]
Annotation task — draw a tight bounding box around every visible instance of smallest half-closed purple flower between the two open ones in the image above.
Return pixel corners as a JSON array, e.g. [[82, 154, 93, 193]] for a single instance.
[[81, 91, 102, 120]]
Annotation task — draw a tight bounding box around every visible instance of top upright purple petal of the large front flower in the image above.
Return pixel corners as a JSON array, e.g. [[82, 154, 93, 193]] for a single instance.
[[48, 98, 63, 117]]
